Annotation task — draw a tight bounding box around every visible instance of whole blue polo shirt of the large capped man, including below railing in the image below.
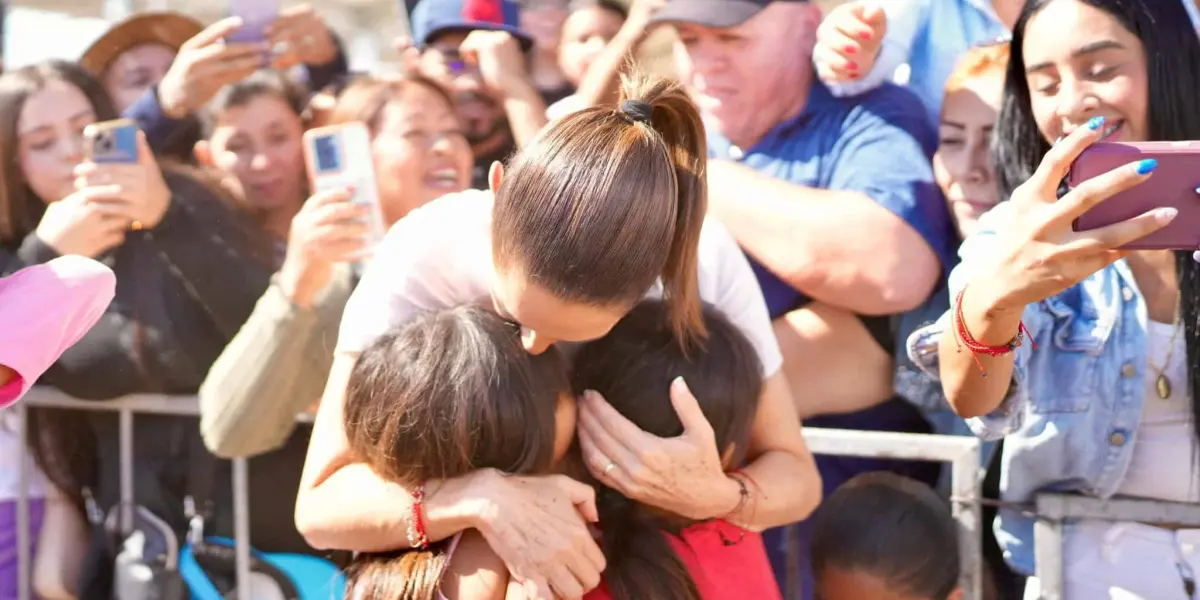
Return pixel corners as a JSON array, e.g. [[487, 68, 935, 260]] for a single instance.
[[708, 82, 958, 600]]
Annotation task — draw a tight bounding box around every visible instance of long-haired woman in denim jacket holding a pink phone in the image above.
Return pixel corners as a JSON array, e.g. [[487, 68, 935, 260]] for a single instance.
[[940, 0, 1200, 600]]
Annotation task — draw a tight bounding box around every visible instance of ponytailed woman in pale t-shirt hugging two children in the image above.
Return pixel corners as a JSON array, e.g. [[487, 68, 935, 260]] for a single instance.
[[296, 70, 821, 598]]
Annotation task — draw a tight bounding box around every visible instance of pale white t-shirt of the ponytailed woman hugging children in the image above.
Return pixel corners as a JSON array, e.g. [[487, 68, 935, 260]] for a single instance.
[[337, 190, 784, 377]]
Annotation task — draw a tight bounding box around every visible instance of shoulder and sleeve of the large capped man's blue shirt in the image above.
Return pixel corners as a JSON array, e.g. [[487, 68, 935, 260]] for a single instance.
[[708, 82, 958, 319]]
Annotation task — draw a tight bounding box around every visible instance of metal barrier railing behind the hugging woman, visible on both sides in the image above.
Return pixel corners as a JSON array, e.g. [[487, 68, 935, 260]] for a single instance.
[[17, 388, 983, 600]]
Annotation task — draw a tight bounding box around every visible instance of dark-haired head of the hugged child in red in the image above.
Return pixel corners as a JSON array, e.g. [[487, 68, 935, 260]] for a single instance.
[[571, 300, 762, 466]]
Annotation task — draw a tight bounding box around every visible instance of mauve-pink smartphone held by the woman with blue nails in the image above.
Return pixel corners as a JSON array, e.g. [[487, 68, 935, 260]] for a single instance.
[[1067, 142, 1200, 250]]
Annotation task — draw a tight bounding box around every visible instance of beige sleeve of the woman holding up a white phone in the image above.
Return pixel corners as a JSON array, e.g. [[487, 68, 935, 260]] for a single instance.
[[200, 269, 353, 457]]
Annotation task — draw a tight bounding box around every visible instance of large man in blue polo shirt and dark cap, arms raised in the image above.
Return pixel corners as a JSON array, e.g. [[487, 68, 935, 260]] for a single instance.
[[652, 0, 954, 598]]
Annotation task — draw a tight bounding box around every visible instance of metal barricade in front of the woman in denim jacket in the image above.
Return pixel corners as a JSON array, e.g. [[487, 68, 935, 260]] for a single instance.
[[1033, 493, 1200, 600]]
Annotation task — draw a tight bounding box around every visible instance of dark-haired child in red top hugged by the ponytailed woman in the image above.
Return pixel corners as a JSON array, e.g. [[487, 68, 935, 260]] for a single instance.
[[571, 300, 780, 600]]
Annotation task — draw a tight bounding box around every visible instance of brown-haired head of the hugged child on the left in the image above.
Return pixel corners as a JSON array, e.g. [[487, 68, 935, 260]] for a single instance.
[[344, 306, 575, 481]]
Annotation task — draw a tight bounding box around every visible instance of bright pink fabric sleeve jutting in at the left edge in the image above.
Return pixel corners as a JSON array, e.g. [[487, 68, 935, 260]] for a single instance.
[[0, 256, 116, 408]]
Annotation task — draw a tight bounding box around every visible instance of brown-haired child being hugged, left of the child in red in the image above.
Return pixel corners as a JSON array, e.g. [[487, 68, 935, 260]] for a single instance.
[[343, 306, 575, 600]]
